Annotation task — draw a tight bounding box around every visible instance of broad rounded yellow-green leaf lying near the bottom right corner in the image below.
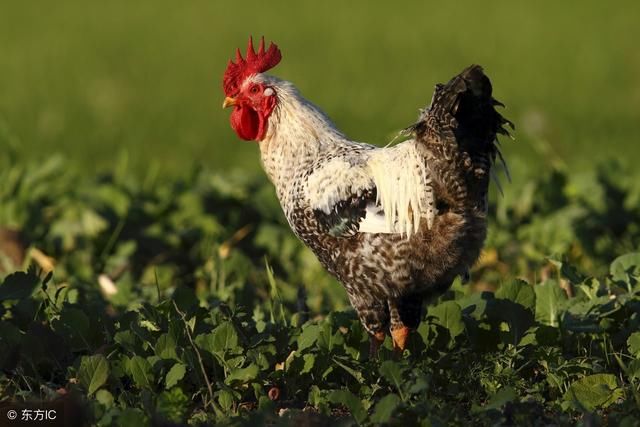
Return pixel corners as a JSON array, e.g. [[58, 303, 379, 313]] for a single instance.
[[563, 374, 624, 411]]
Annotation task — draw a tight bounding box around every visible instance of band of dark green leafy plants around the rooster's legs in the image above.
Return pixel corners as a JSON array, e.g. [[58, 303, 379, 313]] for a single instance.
[[0, 157, 640, 426]]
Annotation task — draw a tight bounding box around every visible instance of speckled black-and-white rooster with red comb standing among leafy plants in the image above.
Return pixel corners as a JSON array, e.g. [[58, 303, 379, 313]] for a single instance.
[[223, 38, 513, 357]]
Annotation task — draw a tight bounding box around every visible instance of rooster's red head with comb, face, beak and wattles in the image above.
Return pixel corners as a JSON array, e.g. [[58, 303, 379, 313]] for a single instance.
[[222, 37, 282, 141]]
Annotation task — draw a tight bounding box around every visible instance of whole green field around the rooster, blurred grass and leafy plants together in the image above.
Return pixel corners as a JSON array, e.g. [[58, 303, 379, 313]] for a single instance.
[[0, 0, 640, 427]]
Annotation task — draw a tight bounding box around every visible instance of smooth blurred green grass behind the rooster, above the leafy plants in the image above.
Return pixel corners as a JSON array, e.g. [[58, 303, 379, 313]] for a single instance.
[[0, 0, 640, 175]]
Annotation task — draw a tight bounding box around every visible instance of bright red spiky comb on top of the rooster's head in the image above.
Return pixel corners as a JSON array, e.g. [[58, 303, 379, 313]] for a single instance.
[[222, 37, 282, 96]]
